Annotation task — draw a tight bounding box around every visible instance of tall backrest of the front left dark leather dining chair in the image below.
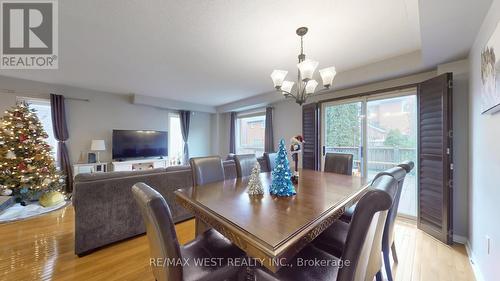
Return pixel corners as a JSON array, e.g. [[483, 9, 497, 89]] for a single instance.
[[132, 183, 182, 281]]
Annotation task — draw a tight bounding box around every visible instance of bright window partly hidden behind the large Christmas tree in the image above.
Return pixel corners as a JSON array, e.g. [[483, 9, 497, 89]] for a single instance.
[[18, 97, 59, 164]]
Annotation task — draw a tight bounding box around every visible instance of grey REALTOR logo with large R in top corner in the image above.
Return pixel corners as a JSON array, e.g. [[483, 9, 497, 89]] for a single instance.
[[0, 0, 58, 69]]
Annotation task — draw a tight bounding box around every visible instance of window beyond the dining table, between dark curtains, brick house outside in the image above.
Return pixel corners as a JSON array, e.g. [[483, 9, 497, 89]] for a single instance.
[[236, 114, 266, 157]]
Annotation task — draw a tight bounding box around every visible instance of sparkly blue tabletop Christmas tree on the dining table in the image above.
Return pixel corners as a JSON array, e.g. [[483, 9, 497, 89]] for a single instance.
[[270, 139, 296, 196]]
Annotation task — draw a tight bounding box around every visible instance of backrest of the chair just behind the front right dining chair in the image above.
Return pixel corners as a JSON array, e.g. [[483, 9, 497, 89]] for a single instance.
[[373, 166, 406, 248]]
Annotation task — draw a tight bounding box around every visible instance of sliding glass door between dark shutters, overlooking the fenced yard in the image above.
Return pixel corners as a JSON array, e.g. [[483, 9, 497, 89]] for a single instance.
[[321, 89, 418, 217]]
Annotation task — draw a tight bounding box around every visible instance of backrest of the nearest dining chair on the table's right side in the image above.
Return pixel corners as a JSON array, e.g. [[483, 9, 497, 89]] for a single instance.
[[337, 176, 396, 281]]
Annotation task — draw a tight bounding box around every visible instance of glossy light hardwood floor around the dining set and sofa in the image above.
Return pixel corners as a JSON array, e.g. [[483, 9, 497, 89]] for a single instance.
[[0, 206, 474, 281]]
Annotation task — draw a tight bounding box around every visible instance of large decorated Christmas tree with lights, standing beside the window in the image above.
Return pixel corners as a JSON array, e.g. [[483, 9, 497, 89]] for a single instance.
[[0, 104, 64, 201]]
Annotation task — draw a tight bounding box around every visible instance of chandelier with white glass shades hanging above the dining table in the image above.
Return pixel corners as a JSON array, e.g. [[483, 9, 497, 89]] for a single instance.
[[271, 27, 337, 105]]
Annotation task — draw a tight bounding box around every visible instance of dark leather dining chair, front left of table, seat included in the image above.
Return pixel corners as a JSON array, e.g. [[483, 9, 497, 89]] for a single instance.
[[132, 183, 246, 281]]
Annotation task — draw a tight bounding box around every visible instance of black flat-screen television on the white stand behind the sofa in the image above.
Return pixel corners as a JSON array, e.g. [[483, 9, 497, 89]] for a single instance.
[[112, 130, 168, 160]]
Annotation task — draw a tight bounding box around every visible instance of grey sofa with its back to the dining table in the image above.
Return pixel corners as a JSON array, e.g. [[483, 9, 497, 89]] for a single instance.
[[72, 161, 236, 256]]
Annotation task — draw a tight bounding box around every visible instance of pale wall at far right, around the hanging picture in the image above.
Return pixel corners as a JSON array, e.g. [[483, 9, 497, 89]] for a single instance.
[[469, 0, 500, 280]]
